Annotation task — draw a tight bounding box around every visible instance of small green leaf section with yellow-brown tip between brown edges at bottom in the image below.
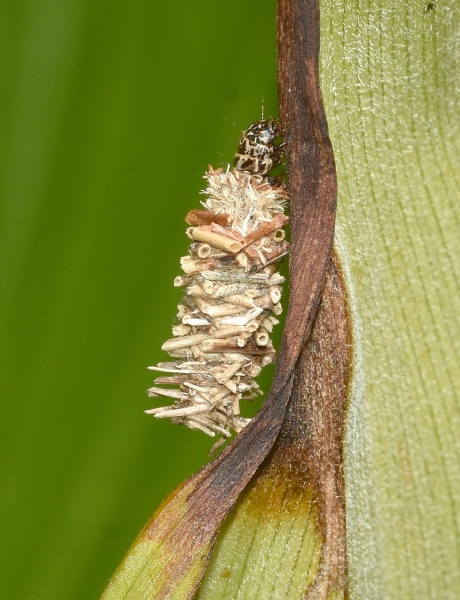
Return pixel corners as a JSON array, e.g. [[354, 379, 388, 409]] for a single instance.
[[196, 463, 323, 600]]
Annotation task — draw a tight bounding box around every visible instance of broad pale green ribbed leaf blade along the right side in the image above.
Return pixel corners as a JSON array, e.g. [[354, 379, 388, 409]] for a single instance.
[[321, 0, 460, 600]]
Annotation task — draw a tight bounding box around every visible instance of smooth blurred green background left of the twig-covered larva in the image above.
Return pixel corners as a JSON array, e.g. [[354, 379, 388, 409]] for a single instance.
[[0, 0, 277, 600]]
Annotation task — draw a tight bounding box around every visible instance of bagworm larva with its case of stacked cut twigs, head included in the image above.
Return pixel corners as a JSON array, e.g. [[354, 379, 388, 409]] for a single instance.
[[146, 119, 289, 449]]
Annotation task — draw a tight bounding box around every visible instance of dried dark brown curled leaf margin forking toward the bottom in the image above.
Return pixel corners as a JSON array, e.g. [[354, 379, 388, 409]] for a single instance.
[[100, 0, 349, 599]]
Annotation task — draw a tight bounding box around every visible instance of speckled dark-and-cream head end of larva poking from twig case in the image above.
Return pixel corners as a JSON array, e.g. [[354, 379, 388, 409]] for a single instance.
[[233, 119, 284, 175]]
